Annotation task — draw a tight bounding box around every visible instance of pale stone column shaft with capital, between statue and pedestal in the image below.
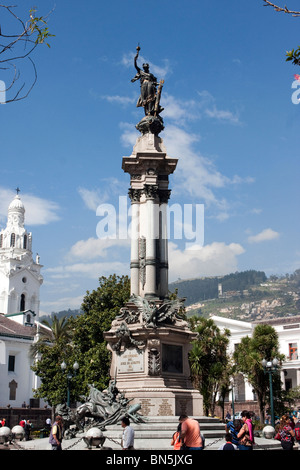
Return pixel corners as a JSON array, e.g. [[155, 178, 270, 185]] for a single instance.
[[122, 133, 177, 299]]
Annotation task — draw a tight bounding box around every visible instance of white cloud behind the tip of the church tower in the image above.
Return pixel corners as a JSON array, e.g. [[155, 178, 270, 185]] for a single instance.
[[0, 188, 60, 225]]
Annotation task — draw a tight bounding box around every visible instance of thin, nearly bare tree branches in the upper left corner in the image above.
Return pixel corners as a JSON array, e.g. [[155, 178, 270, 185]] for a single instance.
[[0, 5, 54, 103]]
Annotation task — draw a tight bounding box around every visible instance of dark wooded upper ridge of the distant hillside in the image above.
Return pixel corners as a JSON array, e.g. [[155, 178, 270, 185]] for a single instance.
[[169, 270, 267, 305]]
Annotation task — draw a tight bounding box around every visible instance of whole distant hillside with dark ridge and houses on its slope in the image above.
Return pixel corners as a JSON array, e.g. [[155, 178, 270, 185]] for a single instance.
[[169, 269, 300, 321]]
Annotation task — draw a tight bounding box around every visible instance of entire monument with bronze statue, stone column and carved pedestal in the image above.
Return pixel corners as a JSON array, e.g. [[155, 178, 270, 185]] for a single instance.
[[104, 48, 203, 416]]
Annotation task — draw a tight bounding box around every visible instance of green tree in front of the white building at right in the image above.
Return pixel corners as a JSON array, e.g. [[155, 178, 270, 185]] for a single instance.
[[233, 325, 284, 423]]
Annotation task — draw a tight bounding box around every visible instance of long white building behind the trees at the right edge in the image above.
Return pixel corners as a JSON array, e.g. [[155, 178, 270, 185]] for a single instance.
[[211, 316, 300, 401]]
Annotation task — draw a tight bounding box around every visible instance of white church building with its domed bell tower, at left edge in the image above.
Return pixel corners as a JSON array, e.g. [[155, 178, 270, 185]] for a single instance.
[[0, 194, 43, 407]]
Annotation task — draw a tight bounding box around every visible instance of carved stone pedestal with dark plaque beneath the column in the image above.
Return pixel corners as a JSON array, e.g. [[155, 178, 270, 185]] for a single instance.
[[105, 304, 203, 416]]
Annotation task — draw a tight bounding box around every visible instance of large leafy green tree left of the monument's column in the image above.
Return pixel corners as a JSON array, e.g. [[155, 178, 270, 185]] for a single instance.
[[32, 275, 130, 405]]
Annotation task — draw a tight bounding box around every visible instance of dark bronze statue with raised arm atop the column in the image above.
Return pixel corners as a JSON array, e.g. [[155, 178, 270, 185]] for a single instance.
[[131, 46, 164, 135]]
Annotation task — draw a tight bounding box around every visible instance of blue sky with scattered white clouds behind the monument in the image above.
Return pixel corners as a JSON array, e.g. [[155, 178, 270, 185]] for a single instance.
[[0, 0, 300, 313]]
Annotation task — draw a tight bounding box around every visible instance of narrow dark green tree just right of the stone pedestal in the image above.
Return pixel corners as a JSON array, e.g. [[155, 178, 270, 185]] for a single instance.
[[189, 317, 230, 415]]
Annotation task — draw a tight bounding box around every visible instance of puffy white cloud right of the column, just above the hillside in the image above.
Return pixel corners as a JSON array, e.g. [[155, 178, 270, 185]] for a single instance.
[[169, 242, 245, 282]]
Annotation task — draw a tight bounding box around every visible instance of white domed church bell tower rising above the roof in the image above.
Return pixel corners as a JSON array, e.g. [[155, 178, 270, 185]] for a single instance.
[[0, 189, 43, 325]]
